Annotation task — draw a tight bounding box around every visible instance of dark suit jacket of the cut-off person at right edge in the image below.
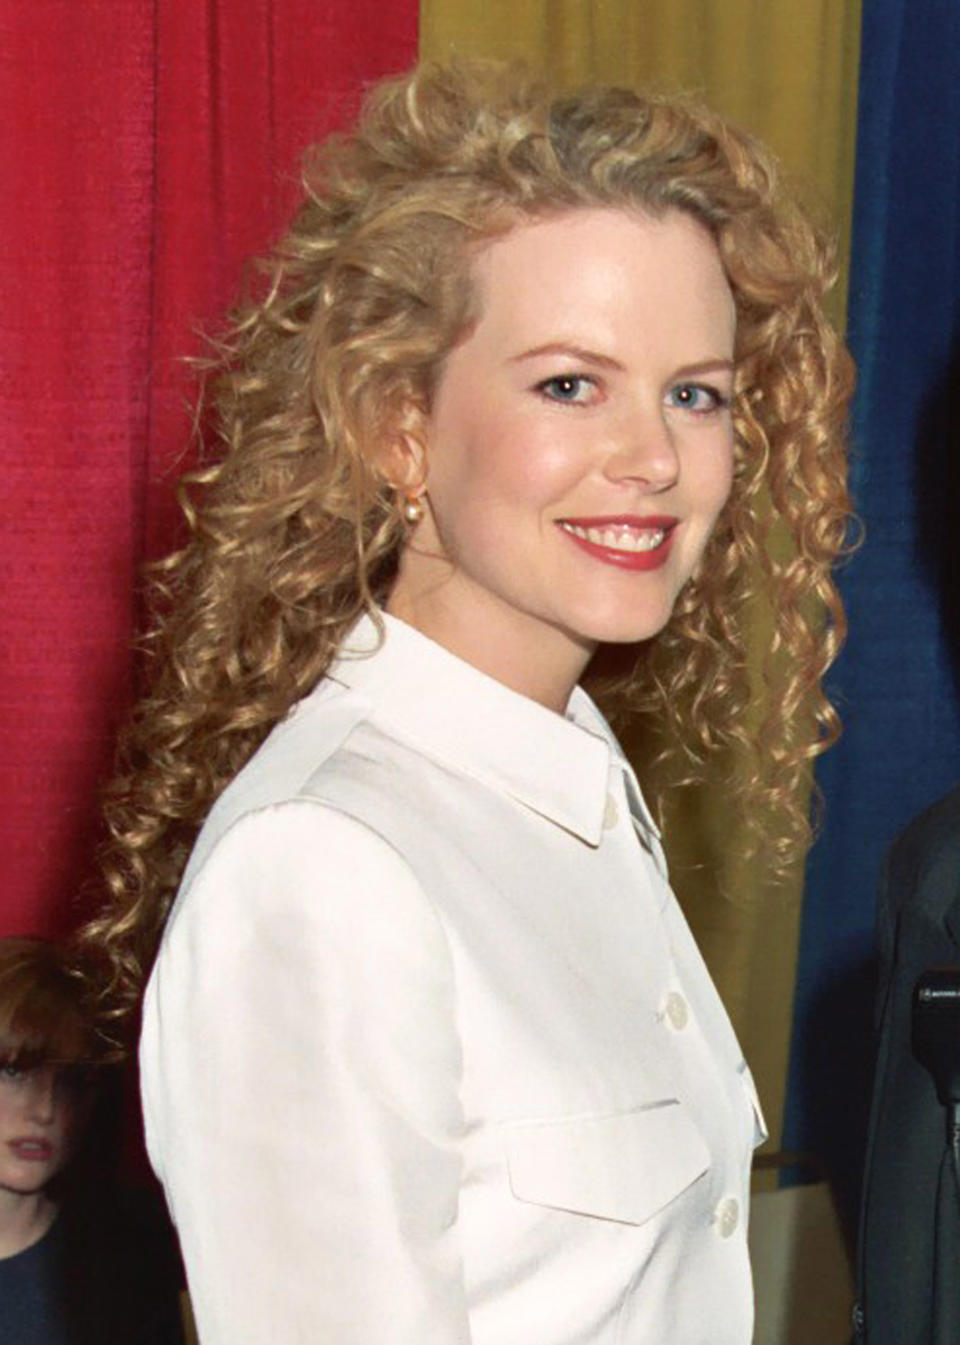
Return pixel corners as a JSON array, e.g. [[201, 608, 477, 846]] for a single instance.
[[859, 790, 960, 1345]]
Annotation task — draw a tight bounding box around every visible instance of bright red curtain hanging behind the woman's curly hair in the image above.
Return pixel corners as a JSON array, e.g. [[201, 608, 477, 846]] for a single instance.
[[0, 0, 417, 933]]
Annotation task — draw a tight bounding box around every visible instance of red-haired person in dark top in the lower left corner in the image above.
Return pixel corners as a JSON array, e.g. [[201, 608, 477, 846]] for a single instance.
[[0, 939, 183, 1345]]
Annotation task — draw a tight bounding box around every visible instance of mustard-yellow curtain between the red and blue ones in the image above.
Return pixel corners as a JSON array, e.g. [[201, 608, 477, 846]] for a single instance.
[[421, 0, 861, 1146]]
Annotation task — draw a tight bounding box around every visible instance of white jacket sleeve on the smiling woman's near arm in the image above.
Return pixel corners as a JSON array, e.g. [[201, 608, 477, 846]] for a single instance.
[[141, 800, 469, 1345]]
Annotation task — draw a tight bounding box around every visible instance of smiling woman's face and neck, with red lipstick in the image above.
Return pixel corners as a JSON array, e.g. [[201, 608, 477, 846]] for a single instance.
[[389, 208, 735, 707]]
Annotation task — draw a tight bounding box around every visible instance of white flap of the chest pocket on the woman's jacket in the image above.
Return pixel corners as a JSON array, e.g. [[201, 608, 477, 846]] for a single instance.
[[504, 1099, 710, 1224]]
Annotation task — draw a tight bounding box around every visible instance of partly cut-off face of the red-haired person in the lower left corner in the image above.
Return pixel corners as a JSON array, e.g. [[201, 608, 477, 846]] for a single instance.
[[0, 1064, 78, 1196]]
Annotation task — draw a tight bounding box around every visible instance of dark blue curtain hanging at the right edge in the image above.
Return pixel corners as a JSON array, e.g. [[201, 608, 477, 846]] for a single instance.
[[784, 0, 960, 1215]]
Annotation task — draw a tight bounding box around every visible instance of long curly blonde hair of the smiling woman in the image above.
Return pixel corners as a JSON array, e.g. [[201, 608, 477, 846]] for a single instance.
[[80, 57, 851, 1014]]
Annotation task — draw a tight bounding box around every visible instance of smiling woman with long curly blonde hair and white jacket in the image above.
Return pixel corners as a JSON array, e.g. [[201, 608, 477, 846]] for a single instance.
[[80, 60, 850, 1345]]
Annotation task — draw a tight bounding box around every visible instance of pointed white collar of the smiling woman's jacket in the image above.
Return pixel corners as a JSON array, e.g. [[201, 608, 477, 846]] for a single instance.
[[328, 612, 652, 846]]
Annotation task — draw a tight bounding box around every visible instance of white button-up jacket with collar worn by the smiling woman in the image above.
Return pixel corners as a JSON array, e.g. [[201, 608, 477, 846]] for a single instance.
[[141, 617, 762, 1345]]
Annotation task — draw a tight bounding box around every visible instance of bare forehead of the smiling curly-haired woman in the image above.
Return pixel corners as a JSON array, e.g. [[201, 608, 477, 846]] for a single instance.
[[462, 208, 735, 354]]
